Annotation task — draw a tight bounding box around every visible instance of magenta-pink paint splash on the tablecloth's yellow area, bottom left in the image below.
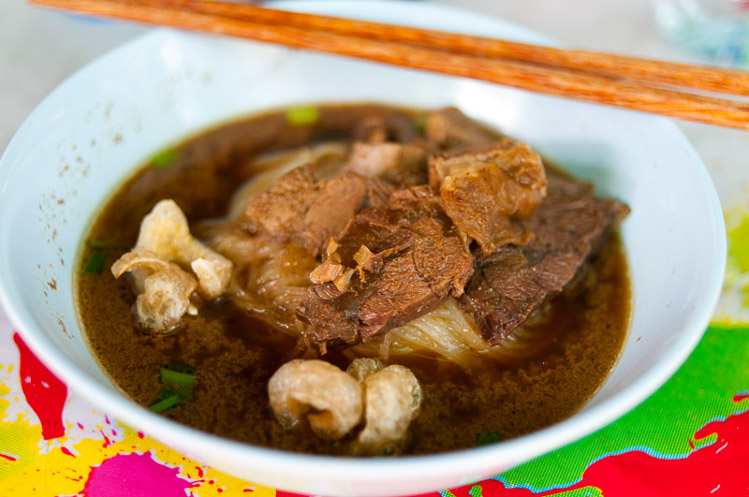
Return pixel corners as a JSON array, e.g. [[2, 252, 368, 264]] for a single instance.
[[81, 452, 201, 497]]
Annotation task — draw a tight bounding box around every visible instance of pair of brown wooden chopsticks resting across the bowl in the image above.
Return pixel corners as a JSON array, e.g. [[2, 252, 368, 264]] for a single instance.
[[30, 0, 749, 130]]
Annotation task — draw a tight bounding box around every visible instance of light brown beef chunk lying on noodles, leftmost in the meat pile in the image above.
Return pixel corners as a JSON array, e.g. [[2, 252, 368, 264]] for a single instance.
[[245, 164, 392, 256]]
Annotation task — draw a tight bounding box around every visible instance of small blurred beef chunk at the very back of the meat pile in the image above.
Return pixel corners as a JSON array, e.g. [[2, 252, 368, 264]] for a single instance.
[[425, 107, 501, 152]]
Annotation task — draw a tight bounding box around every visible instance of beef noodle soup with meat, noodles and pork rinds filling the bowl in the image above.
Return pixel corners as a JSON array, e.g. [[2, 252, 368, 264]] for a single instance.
[[76, 105, 630, 455]]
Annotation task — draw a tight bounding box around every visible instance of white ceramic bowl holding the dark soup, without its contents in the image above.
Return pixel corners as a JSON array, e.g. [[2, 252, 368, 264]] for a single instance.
[[0, 1, 725, 496]]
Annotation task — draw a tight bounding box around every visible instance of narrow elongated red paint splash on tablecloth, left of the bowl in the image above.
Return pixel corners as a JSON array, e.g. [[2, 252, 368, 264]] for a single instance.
[[13, 332, 68, 440]]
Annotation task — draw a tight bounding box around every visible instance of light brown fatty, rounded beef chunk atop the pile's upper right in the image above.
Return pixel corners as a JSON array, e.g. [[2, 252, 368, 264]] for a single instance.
[[429, 140, 546, 254]]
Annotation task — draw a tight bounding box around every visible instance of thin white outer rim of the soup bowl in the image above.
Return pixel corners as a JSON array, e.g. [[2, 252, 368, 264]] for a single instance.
[[0, 0, 726, 490]]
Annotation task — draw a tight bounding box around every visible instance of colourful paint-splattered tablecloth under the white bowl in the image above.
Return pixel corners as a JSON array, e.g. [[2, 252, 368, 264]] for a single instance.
[[0, 203, 749, 497]]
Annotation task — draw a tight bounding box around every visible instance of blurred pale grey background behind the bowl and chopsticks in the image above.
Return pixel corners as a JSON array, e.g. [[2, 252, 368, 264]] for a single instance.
[[0, 0, 749, 204]]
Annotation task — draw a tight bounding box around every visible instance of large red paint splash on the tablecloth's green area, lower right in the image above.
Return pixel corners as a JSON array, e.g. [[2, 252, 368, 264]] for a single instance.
[[276, 394, 749, 497]]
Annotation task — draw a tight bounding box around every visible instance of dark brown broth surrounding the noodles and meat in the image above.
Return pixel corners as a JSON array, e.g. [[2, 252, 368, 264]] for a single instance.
[[76, 102, 630, 454]]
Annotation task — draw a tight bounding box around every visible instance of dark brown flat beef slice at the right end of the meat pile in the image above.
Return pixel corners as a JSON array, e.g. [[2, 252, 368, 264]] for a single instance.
[[460, 174, 629, 345]]
